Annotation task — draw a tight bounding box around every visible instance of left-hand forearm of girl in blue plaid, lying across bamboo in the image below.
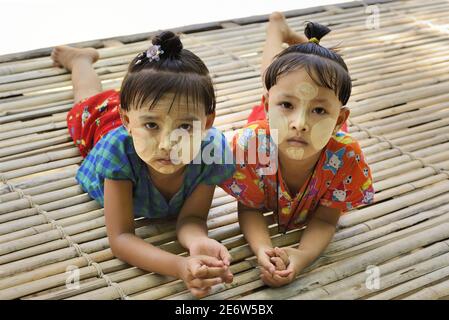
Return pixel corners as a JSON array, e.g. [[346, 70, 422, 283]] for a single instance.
[[110, 233, 184, 278]]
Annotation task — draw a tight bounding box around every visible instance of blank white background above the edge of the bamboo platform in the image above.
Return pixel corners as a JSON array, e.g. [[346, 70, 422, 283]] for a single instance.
[[0, 0, 349, 55]]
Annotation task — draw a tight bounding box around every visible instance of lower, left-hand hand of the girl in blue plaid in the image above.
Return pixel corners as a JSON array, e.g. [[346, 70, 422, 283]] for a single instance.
[[178, 256, 228, 298]]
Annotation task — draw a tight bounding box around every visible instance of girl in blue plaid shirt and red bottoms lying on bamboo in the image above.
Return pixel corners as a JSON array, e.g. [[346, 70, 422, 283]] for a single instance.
[[52, 31, 235, 297]]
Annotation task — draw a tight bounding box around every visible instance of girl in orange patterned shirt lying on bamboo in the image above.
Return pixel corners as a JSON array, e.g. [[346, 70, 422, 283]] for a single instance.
[[220, 13, 374, 286]]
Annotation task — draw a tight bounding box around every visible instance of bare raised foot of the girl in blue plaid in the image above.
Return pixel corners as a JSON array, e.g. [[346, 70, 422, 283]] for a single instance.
[[51, 46, 99, 71]]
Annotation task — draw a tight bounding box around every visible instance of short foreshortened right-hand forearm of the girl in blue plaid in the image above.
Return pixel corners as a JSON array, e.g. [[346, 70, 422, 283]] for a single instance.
[[176, 216, 208, 249]]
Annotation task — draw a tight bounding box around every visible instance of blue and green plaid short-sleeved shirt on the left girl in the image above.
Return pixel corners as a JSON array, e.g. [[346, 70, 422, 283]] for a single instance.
[[76, 126, 235, 218]]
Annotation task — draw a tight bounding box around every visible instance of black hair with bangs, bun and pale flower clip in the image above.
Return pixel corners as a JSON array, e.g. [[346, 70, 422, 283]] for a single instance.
[[120, 31, 216, 115]]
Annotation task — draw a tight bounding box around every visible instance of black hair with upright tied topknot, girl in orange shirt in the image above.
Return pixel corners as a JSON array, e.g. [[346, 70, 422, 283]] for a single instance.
[[264, 22, 352, 106]]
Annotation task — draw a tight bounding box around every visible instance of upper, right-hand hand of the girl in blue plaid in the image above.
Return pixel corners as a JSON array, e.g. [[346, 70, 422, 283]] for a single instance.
[[189, 238, 233, 283]]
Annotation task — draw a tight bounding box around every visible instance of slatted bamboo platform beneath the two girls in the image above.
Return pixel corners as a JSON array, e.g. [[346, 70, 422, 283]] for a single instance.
[[0, 0, 449, 299]]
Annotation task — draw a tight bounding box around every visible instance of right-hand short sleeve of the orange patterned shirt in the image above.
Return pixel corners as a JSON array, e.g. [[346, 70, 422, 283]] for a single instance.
[[320, 142, 374, 213]]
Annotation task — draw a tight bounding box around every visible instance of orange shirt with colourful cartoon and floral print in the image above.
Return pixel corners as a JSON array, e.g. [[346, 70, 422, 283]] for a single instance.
[[220, 120, 374, 230]]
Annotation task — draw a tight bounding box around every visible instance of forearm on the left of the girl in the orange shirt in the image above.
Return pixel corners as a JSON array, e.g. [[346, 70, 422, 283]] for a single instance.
[[239, 207, 272, 254]]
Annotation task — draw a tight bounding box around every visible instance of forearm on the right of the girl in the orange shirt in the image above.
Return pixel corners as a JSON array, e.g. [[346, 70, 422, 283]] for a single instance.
[[297, 218, 335, 266]]
